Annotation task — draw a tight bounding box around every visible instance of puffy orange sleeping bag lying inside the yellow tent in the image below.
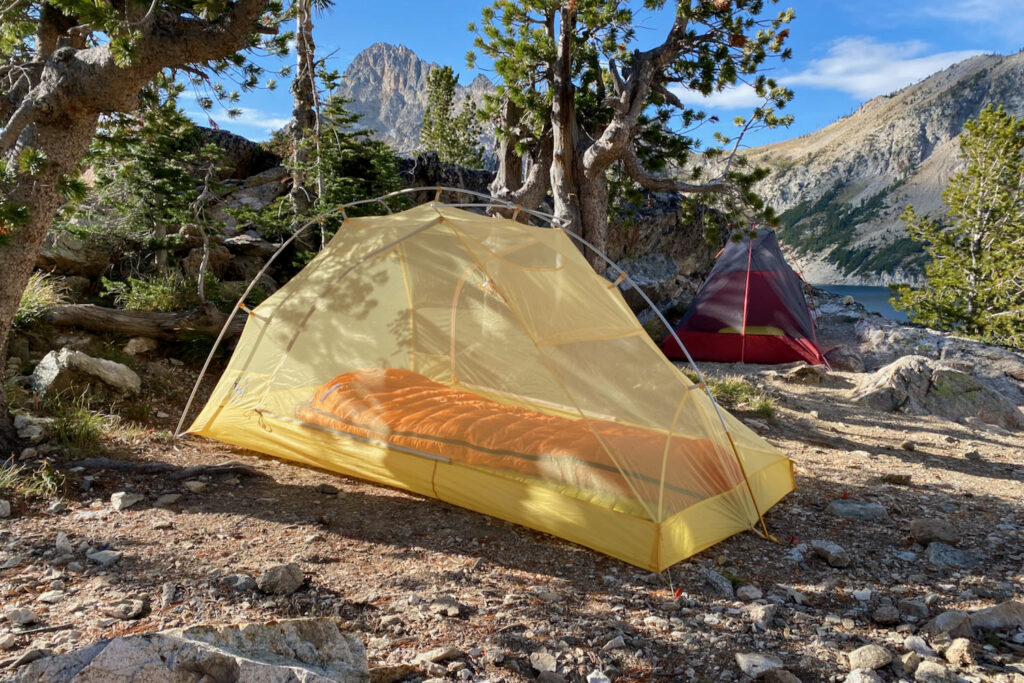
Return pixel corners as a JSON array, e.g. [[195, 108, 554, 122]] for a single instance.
[[296, 369, 742, 510]]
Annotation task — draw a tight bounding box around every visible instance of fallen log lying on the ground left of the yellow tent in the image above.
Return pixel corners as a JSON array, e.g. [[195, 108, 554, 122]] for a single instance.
[[45, 303, 246, 341]]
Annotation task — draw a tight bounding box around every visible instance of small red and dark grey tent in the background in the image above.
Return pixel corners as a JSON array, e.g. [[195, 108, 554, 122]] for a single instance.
[[662, 229, 825, 365]]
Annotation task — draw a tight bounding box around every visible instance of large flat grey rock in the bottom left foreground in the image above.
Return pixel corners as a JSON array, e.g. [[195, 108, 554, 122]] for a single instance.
[[11, 618, 370, 683]]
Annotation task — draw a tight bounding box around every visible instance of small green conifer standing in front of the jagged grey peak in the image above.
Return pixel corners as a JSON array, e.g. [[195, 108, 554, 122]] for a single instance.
[[420, 67, 483, 168]]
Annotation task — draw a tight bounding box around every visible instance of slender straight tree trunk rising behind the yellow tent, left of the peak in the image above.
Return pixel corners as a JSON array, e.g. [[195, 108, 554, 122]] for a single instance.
[[290, 0, 316, 225]]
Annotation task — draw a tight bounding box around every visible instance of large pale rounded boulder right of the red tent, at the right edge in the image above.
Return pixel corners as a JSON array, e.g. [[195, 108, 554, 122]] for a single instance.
[[851, 355, 1024, 429]]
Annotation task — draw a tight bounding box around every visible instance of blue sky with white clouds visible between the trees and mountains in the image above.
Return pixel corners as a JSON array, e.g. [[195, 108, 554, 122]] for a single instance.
[[183, 0, 1024, 145]]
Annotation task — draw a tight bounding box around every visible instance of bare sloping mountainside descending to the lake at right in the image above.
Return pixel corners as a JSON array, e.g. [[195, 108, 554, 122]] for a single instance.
[[748, 52, 1024, 285]]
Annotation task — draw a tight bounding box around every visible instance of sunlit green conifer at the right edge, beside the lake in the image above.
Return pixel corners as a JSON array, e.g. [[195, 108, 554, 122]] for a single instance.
[[892, 105, 1024, 347]]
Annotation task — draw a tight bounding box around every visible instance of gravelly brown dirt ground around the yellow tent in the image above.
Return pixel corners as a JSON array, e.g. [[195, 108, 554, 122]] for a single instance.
[[0, 321, 1024, 682]]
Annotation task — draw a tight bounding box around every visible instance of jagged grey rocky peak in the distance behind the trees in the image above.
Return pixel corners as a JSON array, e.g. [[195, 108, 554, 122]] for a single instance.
[[339, 43, 494, 154]]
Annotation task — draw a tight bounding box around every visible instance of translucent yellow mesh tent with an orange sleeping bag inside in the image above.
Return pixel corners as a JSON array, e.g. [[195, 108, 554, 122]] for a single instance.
[[189, 204, 794, 571]]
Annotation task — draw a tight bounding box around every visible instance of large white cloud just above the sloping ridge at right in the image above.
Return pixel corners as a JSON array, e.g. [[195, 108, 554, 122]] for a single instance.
[[779, 38, 985, 99]]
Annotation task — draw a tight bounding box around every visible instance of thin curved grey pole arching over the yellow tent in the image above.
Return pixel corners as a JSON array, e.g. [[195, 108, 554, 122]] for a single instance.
[[174, 185, 774, 540]]
